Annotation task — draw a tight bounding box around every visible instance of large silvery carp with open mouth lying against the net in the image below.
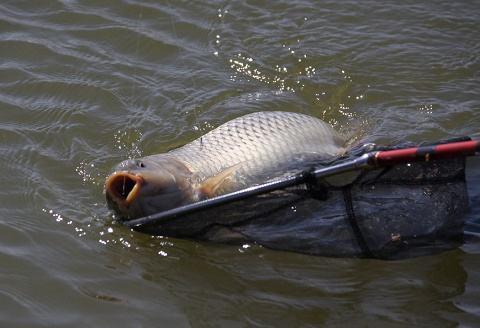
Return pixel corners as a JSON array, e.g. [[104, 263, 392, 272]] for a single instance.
[[105, 111, 345, 220]]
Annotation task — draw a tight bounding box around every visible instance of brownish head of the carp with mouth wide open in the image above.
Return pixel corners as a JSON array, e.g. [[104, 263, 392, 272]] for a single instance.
[[105, 156, 192, 220]]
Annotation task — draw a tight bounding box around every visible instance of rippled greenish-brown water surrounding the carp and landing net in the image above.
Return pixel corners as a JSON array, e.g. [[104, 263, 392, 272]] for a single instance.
[[0, 0, 480, 327]]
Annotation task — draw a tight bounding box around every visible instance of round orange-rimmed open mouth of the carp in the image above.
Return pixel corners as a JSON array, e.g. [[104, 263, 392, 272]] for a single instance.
[[105, 172, 143, 206]]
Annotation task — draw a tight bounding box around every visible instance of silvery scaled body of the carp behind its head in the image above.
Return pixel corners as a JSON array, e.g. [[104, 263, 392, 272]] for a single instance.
[[168, 112, 344, 178]]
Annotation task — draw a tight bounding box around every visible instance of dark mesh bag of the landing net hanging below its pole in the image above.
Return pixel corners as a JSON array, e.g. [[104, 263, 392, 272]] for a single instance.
[[124, 140, 478, 258]]
